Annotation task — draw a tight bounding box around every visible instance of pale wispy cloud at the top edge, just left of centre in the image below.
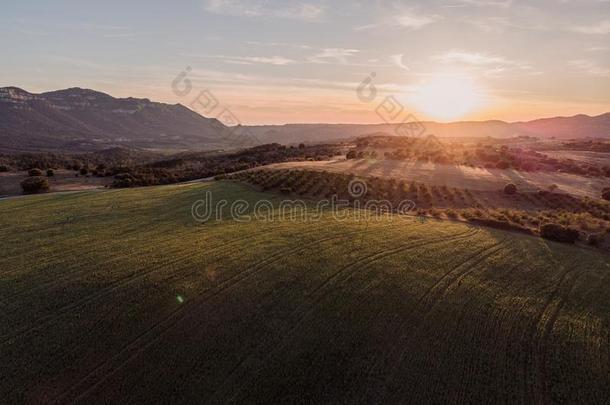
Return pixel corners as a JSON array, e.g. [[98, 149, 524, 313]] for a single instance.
[[203, 0, 324, 21]]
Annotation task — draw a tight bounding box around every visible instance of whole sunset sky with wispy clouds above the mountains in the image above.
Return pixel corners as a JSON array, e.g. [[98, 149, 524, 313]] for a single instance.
[[0, 0, 610, 124]]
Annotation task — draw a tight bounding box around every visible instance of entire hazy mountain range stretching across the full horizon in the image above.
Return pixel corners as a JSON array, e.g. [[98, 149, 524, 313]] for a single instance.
[[0, 87, 610, 151]]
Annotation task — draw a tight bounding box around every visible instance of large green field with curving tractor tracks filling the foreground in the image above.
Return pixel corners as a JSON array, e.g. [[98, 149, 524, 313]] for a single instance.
[[0, 182, 610, 404]]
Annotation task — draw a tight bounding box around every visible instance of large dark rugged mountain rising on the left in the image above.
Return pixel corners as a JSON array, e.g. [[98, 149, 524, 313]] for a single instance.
[[0, 87, 226, 151]]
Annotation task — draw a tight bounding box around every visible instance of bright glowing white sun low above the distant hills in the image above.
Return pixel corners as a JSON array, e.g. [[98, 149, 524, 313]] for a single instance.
[[410, 76, 483, 120]]
